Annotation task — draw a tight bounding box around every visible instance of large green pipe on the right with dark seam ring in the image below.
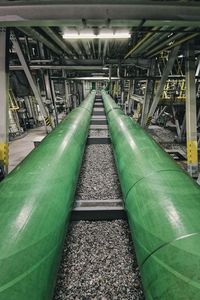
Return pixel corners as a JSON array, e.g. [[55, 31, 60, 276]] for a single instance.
[[102, 91, 200, 300]]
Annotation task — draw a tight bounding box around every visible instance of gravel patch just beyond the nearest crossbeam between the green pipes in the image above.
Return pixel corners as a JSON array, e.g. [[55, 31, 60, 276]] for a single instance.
[[76, 144, 122, 200]]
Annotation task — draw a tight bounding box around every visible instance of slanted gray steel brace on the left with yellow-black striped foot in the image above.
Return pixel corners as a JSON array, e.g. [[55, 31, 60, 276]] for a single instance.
[[10, 32, 52, 127]]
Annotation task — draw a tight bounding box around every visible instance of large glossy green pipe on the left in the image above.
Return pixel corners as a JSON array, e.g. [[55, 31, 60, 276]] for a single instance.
[[0, 91, 95, 300]]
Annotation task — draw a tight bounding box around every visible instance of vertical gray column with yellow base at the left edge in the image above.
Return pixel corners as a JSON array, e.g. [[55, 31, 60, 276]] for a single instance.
[[0, 28, 9, 173]]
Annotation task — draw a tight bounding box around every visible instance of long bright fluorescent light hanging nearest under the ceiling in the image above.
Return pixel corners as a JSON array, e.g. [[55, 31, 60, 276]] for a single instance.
[[63, 29, 131, 40]]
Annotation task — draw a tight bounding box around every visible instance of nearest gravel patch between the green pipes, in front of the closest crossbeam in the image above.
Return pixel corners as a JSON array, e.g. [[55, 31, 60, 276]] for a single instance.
[[54, 220, 144, 300]]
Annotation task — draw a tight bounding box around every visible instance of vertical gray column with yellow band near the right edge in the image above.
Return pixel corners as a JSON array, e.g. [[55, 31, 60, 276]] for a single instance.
[[185, 43, 198, 177]]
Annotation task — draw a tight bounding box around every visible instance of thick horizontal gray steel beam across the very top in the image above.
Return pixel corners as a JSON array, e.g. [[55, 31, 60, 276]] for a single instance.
[[0, 0, 200, 26]]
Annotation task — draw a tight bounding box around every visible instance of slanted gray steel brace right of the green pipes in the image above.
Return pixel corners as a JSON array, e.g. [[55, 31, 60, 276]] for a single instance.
[[146, 46, 180, 126]]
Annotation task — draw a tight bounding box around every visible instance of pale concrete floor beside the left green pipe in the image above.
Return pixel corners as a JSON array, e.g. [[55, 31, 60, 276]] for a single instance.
[[8, 126, 46, 173]]
